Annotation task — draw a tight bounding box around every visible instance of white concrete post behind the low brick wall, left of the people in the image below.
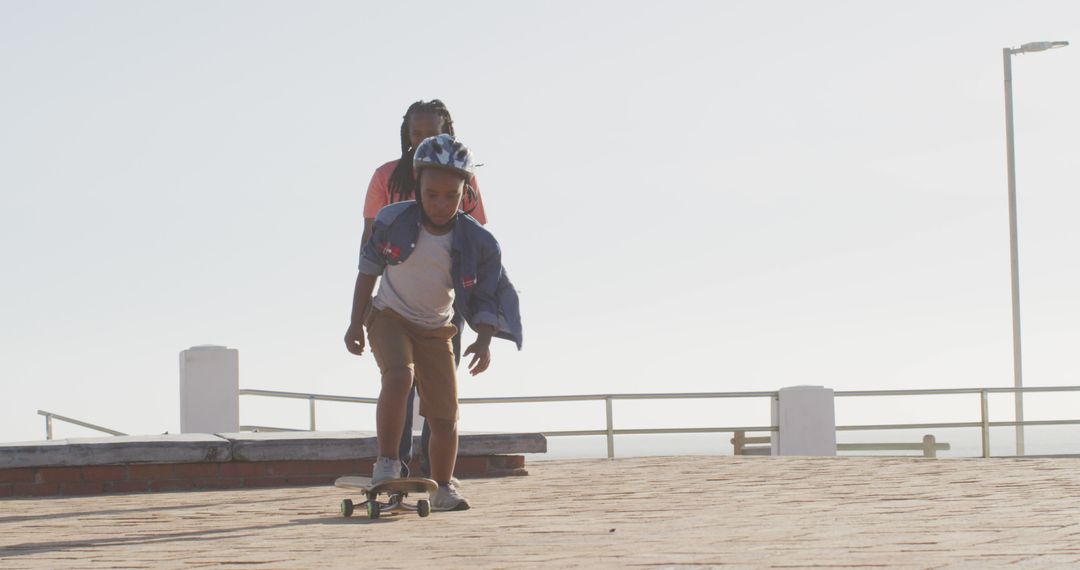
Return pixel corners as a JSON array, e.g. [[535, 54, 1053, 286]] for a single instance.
[[180, 347, 240, 434]]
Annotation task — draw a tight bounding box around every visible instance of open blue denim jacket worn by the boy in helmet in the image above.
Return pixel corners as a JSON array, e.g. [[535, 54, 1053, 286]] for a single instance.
[[360, 201, 522, 350]]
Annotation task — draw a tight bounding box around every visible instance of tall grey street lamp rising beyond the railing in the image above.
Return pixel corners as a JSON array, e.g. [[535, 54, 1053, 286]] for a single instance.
[[1002, 41, 1069, 456]]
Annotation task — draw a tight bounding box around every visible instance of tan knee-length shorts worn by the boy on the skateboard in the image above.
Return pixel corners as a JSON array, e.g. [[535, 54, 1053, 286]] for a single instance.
[[367, 307, 458, 421]]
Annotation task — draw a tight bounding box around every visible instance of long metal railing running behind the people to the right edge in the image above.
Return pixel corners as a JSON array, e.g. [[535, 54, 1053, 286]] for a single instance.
[[240, 386, 1080, 458]]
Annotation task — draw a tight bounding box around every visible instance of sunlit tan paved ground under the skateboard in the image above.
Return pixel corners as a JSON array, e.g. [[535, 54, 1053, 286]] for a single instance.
[[0, 457, 1080, 569]]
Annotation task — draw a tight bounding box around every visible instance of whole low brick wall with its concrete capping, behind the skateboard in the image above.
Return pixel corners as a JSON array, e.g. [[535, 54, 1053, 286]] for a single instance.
[[0, 432, 548, 498]]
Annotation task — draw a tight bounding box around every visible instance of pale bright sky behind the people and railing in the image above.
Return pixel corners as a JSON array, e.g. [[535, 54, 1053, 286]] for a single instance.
[[0, 0, 1080, 449]]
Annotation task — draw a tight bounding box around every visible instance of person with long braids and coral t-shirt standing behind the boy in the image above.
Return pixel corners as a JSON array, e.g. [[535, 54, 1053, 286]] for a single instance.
[[362, 99, 487, 476]]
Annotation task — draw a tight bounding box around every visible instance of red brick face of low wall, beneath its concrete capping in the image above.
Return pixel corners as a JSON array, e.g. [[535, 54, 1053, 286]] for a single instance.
[[0, 456, 528, 498]]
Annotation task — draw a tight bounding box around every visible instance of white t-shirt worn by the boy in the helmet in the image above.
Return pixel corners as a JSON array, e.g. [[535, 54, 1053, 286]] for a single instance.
[[372, 227, 454, 329]]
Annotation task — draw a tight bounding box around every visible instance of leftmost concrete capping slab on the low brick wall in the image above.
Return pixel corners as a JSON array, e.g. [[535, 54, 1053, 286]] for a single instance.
[[0, 434, 232, 470]]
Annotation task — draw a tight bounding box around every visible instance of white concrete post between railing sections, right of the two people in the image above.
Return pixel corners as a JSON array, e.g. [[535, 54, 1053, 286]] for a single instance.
[[772, 385, 836, 456]]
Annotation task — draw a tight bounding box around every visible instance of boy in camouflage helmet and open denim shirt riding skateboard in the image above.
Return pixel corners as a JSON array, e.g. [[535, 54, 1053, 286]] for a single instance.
[[345, 134, 522, 511]]
